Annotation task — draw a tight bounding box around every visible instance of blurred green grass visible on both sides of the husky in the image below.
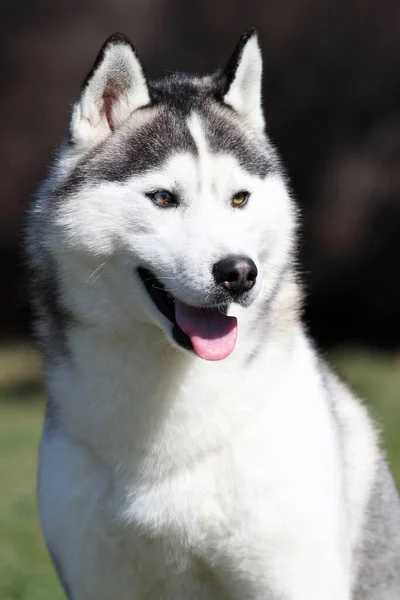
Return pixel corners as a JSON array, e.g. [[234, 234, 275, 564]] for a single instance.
[[0, 343, 400, 600]]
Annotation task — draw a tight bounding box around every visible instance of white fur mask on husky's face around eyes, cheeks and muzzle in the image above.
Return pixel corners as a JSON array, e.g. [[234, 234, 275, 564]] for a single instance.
[[48, 115, 294, 342]]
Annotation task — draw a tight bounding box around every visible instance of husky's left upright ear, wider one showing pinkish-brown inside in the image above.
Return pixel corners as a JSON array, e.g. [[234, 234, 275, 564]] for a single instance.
[[70, 33, 150, 148]]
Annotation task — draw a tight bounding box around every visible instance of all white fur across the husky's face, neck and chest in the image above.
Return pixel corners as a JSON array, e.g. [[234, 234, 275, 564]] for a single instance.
[[35, 109, 382, 600]]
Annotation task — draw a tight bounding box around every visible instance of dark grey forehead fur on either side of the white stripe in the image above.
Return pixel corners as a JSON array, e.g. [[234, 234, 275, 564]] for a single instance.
[[57, 95, 278, 200]]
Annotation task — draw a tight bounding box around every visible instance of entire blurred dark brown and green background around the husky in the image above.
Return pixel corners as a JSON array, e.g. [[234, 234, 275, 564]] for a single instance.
[[0, 0, 400, 600]]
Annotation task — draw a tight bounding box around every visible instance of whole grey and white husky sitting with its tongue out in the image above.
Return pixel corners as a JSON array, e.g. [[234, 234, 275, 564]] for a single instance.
[[27, 30, 400, 600]]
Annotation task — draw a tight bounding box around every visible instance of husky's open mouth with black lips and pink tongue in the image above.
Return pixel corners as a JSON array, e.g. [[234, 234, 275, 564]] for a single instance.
[[138, 267, 237, 360]]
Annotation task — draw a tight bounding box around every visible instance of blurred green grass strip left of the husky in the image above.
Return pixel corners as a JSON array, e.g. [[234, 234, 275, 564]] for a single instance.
[[0, 345, 64, 600]]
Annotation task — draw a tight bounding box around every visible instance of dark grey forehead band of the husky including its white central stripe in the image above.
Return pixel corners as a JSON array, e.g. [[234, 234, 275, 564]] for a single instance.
[[57, 101, 277, 199]]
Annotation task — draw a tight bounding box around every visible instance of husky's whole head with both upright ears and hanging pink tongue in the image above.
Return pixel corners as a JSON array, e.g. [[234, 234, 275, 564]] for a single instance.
[[33, 33, 294, 360]]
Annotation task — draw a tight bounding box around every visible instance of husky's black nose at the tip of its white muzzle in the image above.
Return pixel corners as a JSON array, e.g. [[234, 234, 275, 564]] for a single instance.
[[213, 256, 258, 296]]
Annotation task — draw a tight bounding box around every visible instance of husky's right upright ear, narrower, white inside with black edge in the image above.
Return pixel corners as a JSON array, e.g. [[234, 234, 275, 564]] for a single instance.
[[223, 29, 264, 130]]
